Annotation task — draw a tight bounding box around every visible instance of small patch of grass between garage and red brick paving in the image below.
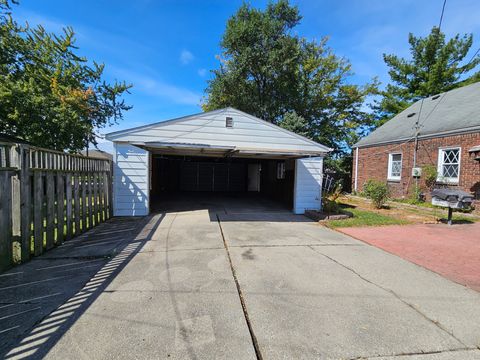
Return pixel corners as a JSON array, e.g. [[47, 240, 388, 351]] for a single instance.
[[325, 205, 410, 228]]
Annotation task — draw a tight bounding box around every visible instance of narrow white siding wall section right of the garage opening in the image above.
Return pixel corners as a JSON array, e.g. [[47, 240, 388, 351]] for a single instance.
[[293, 157, 323, 214]]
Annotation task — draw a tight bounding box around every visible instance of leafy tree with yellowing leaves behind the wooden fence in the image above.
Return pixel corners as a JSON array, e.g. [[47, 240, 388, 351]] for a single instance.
[[0, 0, 131, 152]]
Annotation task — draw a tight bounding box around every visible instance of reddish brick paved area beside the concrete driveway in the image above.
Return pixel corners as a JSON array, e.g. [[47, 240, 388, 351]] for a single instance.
[[339, 223, 480, 291]]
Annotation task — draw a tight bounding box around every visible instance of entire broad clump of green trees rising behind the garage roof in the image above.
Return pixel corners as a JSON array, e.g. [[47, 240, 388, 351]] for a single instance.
[[203, 0, 376, 153]]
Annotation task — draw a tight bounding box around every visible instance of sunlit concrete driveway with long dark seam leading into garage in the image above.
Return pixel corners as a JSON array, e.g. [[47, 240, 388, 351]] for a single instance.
[[2, 195, 480, 360]]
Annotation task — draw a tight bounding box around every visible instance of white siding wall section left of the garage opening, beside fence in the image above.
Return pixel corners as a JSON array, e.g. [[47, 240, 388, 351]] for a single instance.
[[113, 143, 149, 216]]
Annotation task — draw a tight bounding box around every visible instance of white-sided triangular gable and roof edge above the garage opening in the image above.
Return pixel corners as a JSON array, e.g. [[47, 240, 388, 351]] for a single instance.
[[106, 107, 332, 157]]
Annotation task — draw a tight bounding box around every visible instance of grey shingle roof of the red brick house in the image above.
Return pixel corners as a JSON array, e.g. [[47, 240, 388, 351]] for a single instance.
[[353, 82, 480, 147]]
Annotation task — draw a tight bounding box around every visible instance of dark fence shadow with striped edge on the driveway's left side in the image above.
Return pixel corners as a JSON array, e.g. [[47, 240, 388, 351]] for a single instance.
[[0, 215, 164, 359]]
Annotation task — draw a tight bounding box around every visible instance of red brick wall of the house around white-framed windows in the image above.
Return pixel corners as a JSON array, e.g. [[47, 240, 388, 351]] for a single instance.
[[352, 132, 480, 197]]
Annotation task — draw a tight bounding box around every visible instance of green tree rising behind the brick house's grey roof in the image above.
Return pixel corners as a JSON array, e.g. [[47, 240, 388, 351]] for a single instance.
[[375, 27, 480, 122]]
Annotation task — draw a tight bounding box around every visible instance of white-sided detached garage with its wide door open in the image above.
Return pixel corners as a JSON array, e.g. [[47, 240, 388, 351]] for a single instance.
[[106, 108, 331, 216]]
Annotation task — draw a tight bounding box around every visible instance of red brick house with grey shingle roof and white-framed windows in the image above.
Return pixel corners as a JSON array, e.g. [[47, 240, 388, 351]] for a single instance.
[[352, 82, 480, 199]]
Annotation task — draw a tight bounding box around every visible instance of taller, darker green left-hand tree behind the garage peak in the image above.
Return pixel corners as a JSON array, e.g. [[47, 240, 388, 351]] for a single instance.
[[204, 1, 300, 123]]
